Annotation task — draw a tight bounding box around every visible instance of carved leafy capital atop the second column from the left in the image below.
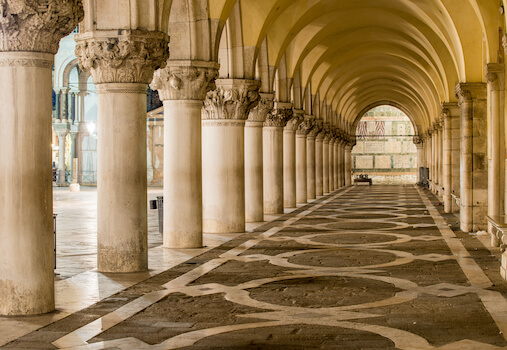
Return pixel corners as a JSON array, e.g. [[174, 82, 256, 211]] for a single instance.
[[75, 30, 169, 84]]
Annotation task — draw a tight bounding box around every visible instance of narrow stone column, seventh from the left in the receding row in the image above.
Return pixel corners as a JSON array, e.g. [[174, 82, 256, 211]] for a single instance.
[[283, 115, 301, 208]]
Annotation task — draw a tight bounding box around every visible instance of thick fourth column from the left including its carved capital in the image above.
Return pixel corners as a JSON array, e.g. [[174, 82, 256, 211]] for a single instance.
[[202, 79, 260, 233]]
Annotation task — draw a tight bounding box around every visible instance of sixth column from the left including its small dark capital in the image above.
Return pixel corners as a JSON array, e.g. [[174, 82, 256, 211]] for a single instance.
[[263, 102, 293, 214]]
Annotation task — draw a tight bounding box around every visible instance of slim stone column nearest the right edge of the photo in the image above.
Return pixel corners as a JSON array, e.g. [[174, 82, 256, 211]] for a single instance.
[[486, 63, 505, 237]]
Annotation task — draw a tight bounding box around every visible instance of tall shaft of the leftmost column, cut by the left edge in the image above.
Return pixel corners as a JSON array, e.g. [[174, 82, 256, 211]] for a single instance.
[[0, 52, 55, 315]]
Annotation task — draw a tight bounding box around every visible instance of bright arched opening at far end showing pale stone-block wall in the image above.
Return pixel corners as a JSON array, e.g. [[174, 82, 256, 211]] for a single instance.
[[352, 105, 417, 184]]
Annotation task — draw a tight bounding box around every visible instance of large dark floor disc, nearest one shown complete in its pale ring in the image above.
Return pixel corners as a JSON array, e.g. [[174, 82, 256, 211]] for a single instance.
[[248, 276, 402, 308]]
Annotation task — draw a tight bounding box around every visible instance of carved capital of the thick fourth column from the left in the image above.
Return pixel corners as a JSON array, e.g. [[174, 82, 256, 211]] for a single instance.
[[202, 79, 260, 120]]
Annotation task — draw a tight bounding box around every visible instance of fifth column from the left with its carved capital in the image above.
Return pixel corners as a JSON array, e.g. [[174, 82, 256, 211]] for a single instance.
[[245, 93, 274, 222]]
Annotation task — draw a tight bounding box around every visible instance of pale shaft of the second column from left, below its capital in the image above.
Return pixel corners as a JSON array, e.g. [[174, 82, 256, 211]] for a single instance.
[[97, 83, 148, 272]]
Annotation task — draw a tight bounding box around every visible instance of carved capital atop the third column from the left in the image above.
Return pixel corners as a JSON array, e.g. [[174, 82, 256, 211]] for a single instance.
[[150, 60, 219, 101]]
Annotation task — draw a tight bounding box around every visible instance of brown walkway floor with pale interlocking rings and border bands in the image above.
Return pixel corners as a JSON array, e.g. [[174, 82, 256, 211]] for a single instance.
[[0, 186, 507, 350]]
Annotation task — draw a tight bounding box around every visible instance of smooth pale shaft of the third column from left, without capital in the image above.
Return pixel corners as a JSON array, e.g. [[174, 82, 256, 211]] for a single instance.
[[164, 100, 202, 248]]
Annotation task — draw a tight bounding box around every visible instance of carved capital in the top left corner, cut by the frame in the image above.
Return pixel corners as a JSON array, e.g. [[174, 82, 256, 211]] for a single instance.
[[0, 0, 84, 54]]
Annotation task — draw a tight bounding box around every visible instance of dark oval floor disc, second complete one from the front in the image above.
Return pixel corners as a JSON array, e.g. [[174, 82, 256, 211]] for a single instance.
[[287, 249, 398, 267]]
